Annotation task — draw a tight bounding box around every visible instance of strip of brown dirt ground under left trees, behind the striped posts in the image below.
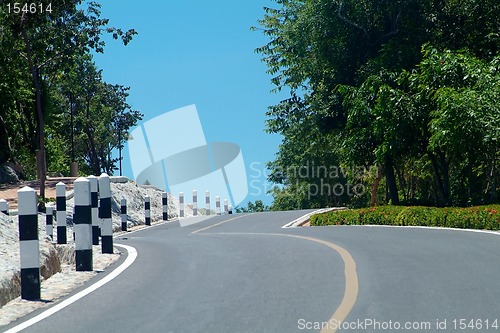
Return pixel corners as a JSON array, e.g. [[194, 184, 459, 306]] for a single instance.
[[0, 177, 76, 210]]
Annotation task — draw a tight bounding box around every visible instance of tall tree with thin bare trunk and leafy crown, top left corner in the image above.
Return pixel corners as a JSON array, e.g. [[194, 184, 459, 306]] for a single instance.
[[0, 0, 136, 197]]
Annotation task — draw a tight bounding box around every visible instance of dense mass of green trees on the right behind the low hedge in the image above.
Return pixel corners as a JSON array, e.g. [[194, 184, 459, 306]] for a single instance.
[[255, 0, 500, 209]]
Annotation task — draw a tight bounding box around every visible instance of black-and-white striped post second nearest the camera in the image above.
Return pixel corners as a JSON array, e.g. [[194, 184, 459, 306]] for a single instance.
[[73, 177, 93, 272]]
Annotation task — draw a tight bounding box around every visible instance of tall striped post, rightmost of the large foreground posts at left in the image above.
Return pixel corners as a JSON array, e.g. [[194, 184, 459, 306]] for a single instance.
[[99, 173, 113, 253]]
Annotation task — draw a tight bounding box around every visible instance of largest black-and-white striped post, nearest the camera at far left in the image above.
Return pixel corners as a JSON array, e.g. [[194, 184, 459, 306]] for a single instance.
[[17, 187, 40, 301]]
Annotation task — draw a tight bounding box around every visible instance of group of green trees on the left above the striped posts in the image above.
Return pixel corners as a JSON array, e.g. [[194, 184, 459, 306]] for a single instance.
[[0, 0, 142, 196]]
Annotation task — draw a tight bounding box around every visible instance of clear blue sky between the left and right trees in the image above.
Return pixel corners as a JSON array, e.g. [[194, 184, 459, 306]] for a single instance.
[[95, 0, 286, 204]]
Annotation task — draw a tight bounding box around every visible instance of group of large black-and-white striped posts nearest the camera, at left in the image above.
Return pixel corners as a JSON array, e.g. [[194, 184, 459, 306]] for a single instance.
[[13, 174, 113, 300]]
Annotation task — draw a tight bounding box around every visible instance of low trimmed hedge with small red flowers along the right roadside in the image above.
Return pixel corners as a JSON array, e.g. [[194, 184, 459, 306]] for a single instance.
[[310, 205, 500, 230]]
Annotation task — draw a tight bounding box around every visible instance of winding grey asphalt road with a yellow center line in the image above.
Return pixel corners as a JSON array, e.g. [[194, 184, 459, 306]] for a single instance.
[[2, 211, 500, 333]]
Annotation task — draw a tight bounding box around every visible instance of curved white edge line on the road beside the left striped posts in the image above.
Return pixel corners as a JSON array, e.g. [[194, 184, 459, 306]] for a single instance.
[[4, 244, 137, 333]]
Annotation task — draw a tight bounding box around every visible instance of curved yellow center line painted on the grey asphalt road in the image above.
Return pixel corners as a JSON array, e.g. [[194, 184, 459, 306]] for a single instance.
[[192, 230, 359, 333]]
